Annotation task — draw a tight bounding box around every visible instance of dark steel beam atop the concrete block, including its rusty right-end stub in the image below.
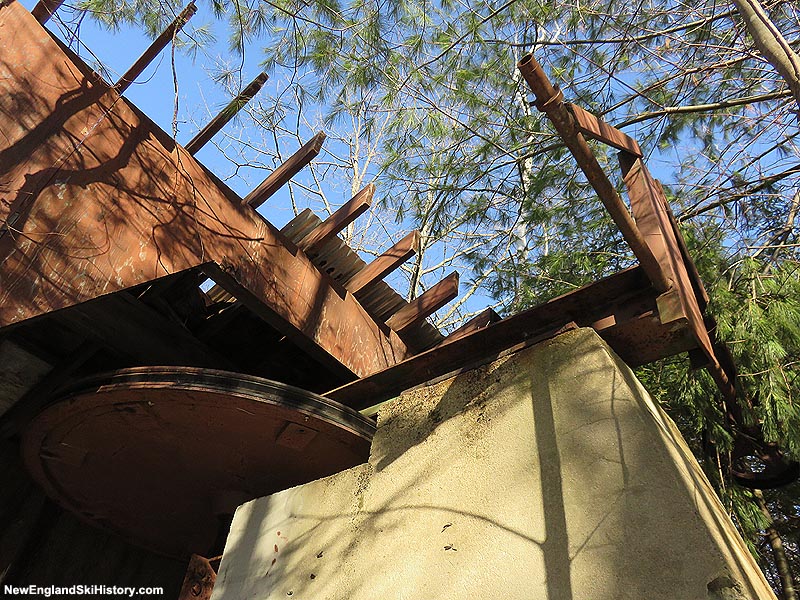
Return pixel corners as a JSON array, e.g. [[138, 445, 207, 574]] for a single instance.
[[325, 266, 680, 410]]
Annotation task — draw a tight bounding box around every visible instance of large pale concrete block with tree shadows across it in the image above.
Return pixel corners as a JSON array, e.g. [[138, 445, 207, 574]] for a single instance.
[[212, 329, 774, 600]]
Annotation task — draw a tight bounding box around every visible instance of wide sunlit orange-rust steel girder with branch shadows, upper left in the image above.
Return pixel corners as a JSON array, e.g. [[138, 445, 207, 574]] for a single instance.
[[0, 3, 409, 377]]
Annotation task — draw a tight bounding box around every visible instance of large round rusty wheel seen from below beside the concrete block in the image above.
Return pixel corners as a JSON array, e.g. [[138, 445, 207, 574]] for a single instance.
[[22, 367, 375, 557]]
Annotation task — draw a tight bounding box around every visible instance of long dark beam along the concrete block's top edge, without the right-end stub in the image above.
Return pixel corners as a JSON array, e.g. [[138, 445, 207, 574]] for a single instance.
[[325, 267, 655, 410]]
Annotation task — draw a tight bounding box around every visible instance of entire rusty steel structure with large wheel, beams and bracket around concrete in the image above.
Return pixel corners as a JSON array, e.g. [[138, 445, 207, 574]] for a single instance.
[[0, 1, 797, 598]]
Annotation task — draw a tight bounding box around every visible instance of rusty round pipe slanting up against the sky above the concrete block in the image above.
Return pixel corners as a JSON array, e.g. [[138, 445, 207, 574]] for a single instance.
[[517, 54, 672, 292]]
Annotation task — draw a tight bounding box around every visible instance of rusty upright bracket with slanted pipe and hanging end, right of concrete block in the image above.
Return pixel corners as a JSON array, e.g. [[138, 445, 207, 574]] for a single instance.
[[518, 55, 800, 488]]
